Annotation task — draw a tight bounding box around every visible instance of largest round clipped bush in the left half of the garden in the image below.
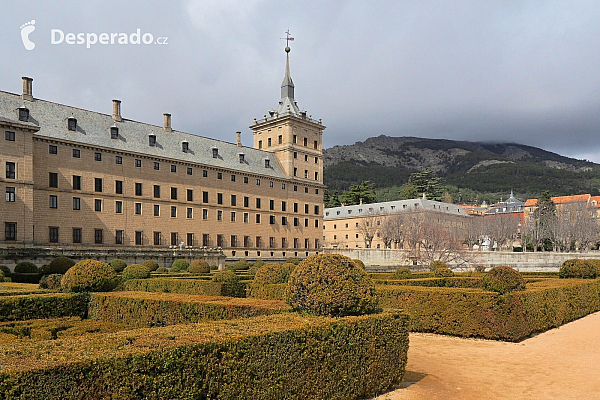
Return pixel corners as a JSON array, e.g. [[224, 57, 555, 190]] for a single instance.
[[61, 260, 119, 292]]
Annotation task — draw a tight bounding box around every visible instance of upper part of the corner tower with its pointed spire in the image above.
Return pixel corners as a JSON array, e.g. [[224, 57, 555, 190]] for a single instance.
[[250, 46, 325, 184]]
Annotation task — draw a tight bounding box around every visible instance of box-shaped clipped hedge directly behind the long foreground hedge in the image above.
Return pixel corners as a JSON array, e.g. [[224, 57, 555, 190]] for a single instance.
[[88, 292, 289, 327]]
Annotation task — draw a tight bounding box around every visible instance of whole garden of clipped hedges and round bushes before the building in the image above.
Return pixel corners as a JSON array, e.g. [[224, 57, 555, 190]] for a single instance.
[[0, 254, 600, 399]]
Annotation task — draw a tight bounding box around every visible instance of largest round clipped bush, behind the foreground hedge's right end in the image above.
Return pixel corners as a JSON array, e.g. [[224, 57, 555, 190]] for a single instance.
[[286, 254, 377, 316]]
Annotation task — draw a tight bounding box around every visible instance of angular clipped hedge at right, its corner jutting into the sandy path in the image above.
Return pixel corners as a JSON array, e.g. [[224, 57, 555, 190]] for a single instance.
[[377, 279, 600, 341]]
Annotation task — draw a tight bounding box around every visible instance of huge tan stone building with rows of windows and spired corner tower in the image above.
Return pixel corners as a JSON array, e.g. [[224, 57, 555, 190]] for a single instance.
[[0, 47, 325, 258]]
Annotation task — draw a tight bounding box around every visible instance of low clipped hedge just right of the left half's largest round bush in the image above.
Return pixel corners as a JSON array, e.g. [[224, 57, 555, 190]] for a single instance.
[[123, 278, 246, 297]]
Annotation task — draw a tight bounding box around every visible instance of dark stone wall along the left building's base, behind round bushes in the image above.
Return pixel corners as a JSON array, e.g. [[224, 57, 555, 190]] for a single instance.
[[0, 247, 225, 270]]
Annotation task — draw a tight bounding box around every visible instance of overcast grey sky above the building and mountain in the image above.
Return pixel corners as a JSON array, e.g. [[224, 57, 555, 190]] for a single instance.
[[0, 0, 600, 162]]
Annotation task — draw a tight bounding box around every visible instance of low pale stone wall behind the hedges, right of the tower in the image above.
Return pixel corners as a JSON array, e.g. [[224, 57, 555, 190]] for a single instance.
[[323, 249, 600, 272]]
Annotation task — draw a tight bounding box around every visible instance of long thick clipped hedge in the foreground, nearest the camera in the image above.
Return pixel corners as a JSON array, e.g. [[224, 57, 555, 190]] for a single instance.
[[0, 313, 408, 400]]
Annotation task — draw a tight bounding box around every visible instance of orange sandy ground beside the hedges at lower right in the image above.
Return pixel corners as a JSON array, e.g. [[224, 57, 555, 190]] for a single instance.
[[377, 312, 600, 400]]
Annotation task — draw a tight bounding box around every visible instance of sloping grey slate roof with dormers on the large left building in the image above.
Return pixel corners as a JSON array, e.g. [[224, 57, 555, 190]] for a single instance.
[[0, 91, 286, 178]]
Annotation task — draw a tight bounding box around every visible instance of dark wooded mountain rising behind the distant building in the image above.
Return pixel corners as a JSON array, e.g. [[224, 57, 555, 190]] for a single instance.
[[323, 135, 600, 202]]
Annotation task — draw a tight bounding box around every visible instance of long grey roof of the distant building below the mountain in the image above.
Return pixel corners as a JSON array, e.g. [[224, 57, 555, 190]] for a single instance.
[[324, 198, 470, 219]]
